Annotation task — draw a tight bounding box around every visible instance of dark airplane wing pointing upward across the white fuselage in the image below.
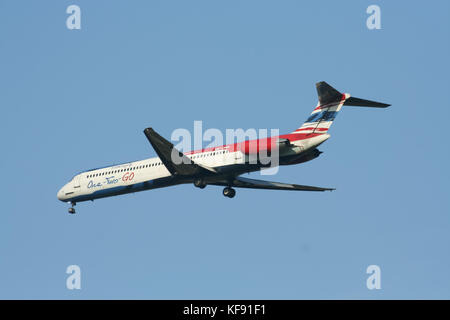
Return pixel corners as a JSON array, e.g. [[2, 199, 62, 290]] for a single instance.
[[144, 128, 216, 176]]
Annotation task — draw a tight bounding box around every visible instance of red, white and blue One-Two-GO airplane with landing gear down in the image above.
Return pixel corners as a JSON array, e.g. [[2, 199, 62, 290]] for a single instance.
[[57, 81, 390, 214]]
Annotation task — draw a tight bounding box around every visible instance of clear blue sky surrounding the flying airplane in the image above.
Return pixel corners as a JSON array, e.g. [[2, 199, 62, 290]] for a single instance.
[[0, 0, 450, 299]]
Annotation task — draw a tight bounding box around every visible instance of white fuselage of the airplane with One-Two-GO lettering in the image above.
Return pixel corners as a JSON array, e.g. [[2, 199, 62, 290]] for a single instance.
[[57, 134, 329, 203]]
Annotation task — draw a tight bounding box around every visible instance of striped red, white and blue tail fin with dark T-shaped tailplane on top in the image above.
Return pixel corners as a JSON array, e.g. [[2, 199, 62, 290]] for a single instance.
[[294, 81, 390, 133]]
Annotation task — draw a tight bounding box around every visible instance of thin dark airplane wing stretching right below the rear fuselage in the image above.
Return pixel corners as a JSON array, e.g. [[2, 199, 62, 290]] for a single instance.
[[208, 177, 335, 191]]
